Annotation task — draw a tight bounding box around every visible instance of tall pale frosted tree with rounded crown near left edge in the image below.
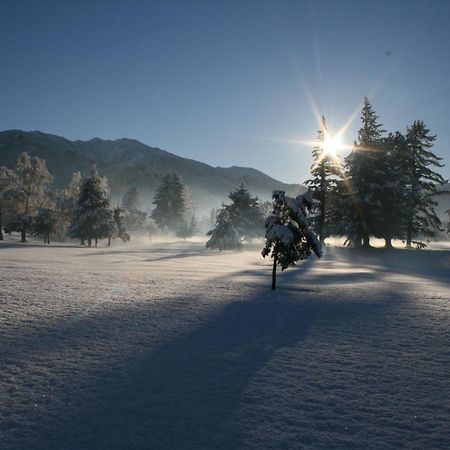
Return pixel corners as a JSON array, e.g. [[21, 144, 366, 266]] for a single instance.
[[7, 152, 52, 242]]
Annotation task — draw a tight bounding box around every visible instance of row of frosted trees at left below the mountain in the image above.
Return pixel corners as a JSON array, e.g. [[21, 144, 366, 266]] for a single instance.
[[0, 159, 197, 246]]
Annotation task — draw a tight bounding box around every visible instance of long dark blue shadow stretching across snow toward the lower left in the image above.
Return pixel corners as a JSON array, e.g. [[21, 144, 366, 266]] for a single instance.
[[14, 297, 315, 449]]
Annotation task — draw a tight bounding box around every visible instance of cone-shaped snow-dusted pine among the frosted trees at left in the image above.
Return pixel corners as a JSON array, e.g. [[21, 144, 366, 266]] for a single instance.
[[68, 164, 116, 247]]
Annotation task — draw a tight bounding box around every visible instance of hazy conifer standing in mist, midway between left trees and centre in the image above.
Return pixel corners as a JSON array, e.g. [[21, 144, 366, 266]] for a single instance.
[[152, 173, 186, 233]]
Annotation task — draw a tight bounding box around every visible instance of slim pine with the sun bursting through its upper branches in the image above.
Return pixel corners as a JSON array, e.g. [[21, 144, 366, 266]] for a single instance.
[[305, 116, 340, 244]]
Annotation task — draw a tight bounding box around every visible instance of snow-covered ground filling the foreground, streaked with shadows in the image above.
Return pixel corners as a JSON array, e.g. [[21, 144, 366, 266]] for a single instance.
[[0, 240, 450, 450]]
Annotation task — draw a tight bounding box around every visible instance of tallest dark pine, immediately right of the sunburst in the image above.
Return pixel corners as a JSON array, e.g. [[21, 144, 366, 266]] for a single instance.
[[341, 97, 384, 247]]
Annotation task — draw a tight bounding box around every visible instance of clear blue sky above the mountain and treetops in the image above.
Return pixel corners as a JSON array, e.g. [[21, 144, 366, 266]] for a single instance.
[[0, 0, 450, 182]]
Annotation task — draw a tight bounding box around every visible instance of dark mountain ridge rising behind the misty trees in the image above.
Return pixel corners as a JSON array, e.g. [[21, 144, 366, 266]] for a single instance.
[[0, 130, 304, 211]]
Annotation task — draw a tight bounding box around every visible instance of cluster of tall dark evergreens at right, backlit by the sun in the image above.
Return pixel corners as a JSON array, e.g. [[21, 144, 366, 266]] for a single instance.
[[305, 97, 450, 248]]
